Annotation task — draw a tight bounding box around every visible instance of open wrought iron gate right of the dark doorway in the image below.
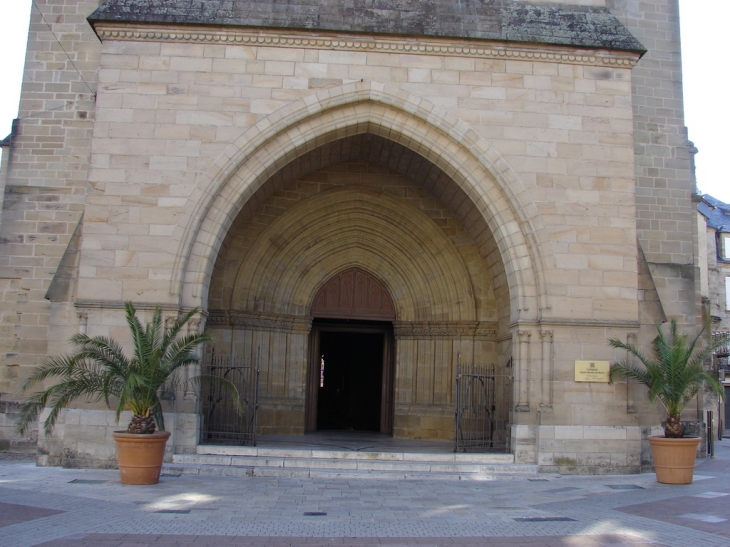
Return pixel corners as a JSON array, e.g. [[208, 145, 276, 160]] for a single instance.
[[455, 359, 512, 452]]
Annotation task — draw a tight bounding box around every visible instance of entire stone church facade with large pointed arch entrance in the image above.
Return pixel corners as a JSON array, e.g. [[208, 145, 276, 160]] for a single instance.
[[0, 0, 710, 473]]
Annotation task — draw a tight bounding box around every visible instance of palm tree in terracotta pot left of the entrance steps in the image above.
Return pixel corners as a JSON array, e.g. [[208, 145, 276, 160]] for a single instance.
[[16, 302, 232, 484]]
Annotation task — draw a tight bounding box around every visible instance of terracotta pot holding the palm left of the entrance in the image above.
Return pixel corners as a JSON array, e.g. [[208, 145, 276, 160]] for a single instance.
[[113, 431, 170, 484]]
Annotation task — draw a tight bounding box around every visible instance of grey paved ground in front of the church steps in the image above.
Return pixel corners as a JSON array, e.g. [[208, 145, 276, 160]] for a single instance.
[[0, 440, 730, 547]]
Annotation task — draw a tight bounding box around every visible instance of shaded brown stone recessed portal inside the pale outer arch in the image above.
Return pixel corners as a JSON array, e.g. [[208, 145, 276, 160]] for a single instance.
[[209, 134, 510, 439]]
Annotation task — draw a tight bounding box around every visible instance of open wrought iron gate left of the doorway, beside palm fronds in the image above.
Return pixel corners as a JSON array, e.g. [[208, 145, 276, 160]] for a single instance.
[[200, 353, 259, 446]]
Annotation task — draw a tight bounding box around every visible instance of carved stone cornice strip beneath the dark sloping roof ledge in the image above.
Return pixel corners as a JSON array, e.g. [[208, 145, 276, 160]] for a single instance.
[[95, 23, 640, 68]]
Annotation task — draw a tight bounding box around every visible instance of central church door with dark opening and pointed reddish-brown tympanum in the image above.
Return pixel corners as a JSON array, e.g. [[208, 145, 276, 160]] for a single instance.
[[305, 268, 395, 435]]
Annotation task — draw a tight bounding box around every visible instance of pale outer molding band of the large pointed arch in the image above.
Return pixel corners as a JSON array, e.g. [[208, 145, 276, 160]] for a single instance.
[[170, 82, 549, 321]]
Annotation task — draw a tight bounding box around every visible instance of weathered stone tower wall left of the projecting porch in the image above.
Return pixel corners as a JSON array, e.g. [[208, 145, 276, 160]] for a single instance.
[[0, 0, 101, 452]]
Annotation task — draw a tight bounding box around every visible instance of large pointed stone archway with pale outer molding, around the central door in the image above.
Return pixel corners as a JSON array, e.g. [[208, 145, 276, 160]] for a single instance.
[[182, 82, 550, 446]]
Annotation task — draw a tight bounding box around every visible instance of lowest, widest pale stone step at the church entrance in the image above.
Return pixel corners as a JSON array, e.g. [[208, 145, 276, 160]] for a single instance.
[[162, 463, 543, 481]]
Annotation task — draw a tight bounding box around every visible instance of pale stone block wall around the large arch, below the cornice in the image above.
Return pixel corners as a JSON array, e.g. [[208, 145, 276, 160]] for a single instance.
[[79, 31, 636, 320]]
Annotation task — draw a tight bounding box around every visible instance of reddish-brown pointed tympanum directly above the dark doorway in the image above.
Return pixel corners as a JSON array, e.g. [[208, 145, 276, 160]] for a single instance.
[[312, 268, 395, 321]]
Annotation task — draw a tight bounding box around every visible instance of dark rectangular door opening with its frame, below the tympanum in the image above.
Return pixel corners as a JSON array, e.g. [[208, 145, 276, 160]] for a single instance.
[[305, 319, 394, 435]]
